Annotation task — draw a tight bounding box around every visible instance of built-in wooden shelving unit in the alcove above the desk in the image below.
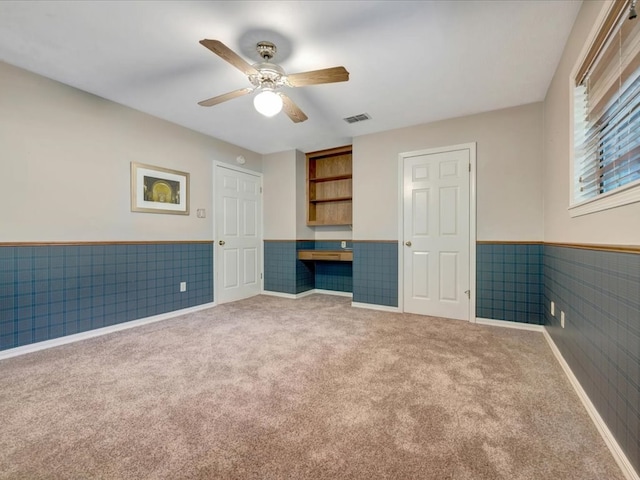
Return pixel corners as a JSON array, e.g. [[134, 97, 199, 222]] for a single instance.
[[306, 145, 353, 225]]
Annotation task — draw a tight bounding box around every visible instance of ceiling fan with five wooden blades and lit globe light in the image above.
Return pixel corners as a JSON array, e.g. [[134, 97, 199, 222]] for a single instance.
[[198, 39, 349, 123]]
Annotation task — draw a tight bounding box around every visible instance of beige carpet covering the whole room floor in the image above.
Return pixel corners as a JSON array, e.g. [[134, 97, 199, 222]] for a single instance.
[[0, 295, 623, 480]]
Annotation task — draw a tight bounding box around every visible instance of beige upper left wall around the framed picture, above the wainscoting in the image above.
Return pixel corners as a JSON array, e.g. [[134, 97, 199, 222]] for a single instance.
[[0, 62, 262, 242]]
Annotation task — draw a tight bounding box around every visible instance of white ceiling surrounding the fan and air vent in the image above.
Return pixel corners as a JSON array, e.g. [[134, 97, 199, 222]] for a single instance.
[[0, 0, 582, 154]]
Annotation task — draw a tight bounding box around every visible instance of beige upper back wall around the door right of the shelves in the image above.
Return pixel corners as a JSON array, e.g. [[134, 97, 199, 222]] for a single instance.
[[353, 103, 543, 241]]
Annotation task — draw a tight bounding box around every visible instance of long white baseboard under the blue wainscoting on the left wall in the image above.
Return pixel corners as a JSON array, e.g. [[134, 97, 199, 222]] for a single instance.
[[0, 302, 216, 360]]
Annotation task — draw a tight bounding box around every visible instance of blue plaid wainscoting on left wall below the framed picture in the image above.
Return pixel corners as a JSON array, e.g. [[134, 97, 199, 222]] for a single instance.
[[0, 242, 213, 350]]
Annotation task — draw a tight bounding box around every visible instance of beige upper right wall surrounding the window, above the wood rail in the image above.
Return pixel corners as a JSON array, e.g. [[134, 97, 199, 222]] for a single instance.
[[544, 0, 640, 245]]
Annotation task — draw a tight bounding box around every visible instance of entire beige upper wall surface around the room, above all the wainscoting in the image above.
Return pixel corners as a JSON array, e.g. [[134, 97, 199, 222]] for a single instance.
[[12, 41, 616, 245]]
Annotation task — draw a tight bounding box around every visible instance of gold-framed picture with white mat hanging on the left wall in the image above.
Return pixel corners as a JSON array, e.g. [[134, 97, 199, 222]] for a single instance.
[[131, 162, 189, 215]]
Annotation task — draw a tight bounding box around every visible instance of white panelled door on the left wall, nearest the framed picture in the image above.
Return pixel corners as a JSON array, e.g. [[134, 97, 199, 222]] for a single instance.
[[214, 165, 262, 303]]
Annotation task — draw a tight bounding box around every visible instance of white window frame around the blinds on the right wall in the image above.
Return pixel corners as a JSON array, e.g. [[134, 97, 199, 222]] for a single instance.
[[568, 1, 640, 217]]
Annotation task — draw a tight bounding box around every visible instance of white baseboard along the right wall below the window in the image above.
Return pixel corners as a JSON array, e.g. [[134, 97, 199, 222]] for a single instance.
[[542, 328, 640, 480]]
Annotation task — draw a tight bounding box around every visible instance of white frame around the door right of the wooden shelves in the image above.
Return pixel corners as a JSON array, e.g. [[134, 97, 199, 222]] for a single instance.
[[398, 142, 476, 323]]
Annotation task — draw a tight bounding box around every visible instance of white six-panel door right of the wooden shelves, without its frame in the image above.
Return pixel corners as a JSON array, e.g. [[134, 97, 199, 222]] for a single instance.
[[400, 149, 471, 320]]
